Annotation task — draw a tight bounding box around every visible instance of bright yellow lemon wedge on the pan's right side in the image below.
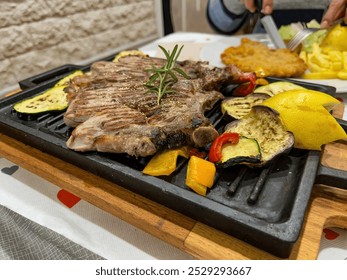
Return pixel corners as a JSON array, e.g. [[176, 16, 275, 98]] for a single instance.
[[263, 90, 347, 150]]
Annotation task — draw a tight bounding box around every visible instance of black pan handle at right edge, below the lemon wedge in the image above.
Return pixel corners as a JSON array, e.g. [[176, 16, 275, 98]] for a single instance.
[[315, 118, 347, 189]]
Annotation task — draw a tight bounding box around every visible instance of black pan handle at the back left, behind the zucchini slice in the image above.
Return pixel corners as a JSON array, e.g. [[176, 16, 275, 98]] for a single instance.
[[18, 64, 83, 90]]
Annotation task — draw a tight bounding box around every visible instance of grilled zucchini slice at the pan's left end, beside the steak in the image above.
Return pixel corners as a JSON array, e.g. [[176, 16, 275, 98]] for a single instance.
[[13, 86, 68, 116]]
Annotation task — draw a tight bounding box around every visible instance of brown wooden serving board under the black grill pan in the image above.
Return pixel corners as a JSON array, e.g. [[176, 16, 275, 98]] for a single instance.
[[0, 93, 347, 260]]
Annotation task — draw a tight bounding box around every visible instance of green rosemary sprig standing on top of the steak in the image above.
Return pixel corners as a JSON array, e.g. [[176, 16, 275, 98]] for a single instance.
[[144, 45, 190, 105]]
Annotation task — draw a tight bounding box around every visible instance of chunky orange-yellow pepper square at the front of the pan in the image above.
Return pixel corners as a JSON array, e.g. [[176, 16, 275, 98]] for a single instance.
[[185, 156, 216, 196]]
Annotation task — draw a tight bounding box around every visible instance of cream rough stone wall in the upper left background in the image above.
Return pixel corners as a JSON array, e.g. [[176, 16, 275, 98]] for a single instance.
[[0, 0, 162, 93]]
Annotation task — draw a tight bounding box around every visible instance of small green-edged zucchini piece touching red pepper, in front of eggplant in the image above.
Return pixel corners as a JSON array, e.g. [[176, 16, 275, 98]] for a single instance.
[[218, 135, 261, 168]]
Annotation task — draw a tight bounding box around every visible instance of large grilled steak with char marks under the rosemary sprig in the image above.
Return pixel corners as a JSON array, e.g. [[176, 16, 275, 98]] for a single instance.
[[64, 56, 256, 157]]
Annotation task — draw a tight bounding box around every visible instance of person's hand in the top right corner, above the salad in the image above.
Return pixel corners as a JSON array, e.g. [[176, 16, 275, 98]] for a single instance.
[[321, 0, 347, 28]]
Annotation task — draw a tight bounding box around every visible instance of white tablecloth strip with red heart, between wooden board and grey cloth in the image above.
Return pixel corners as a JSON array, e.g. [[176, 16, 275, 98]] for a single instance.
[[0, 158, 196, 259]]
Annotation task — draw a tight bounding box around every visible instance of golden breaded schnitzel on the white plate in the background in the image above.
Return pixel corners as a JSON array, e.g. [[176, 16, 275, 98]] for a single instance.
[[221, 38, 308, 78]]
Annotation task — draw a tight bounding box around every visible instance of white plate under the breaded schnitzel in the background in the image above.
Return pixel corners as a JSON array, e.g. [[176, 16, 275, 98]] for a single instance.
[[200, 34, 347, 93]]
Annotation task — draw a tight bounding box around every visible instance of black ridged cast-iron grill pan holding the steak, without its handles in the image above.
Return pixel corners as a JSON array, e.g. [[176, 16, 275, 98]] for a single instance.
[[0, 66, 346, 258]]
